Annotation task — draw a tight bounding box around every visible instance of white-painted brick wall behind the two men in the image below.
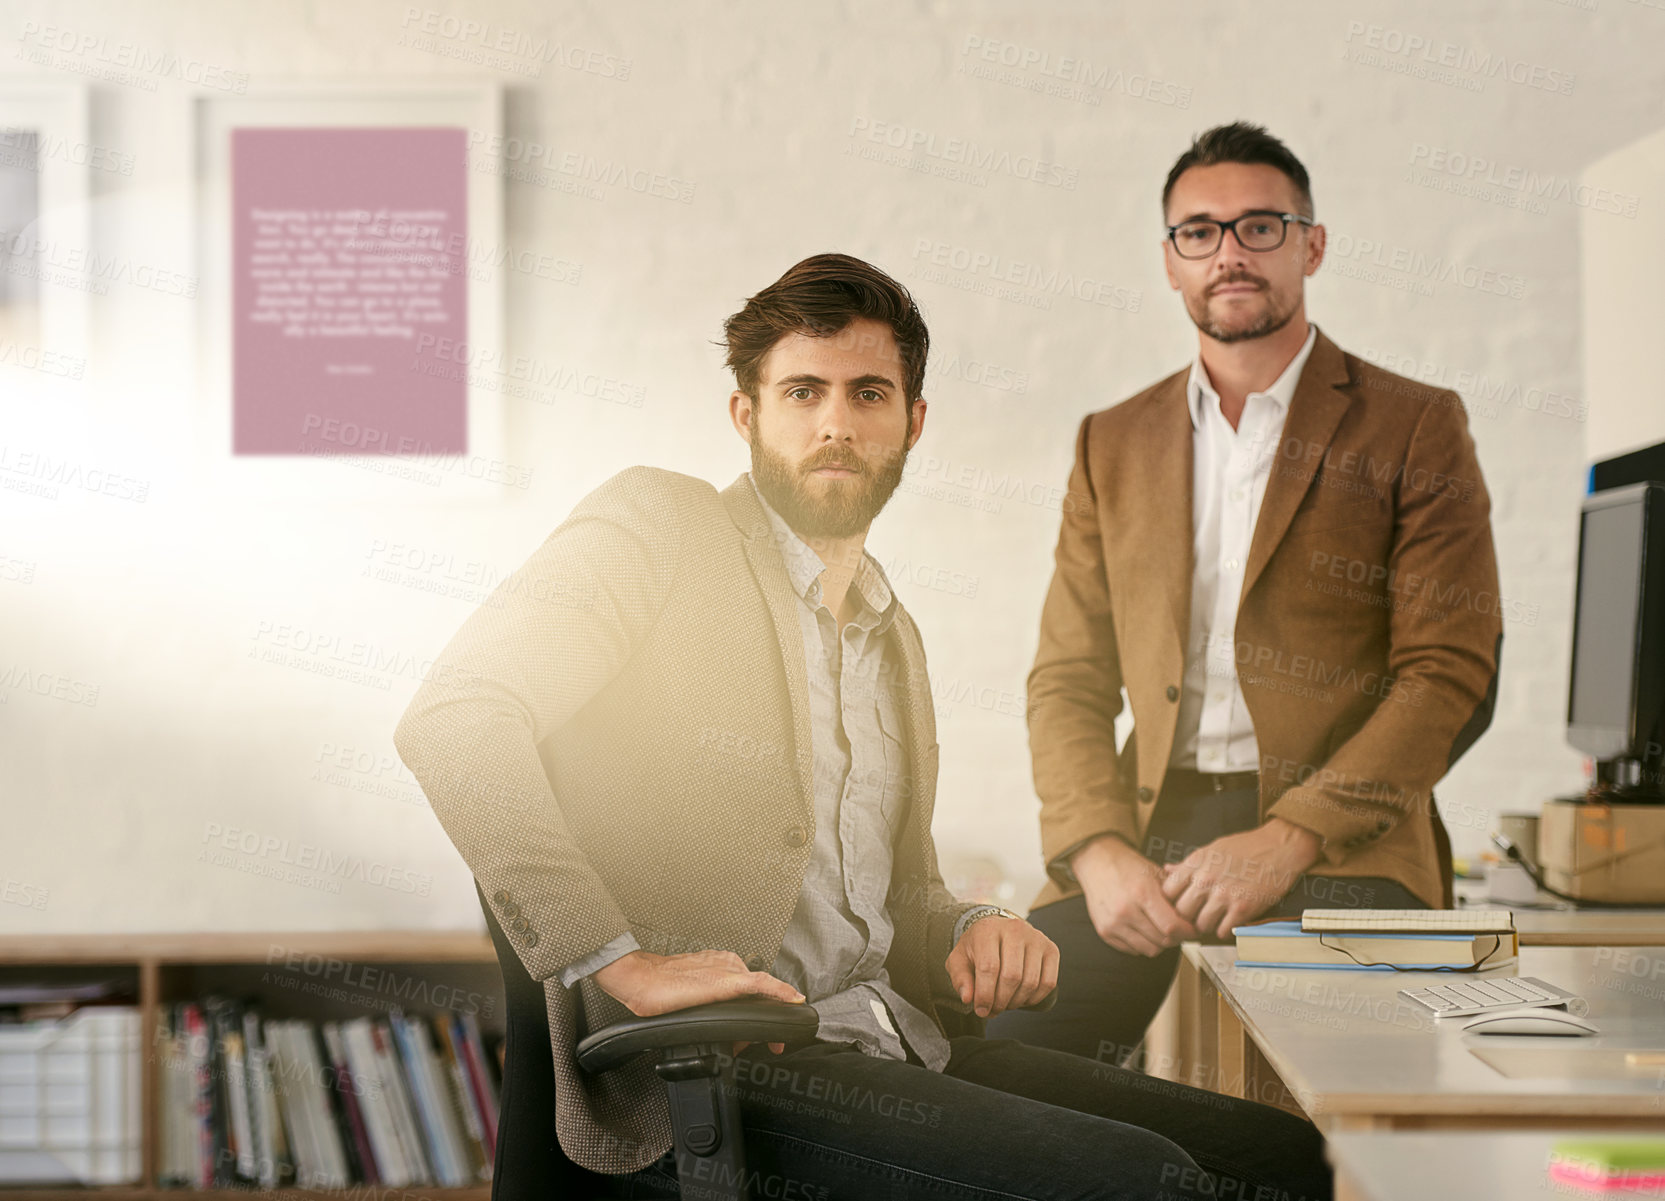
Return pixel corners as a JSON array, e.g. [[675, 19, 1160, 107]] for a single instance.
[[0, 0, 1665, 931]]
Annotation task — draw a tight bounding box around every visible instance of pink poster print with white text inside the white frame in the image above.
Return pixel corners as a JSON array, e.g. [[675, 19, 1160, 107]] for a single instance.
[[231, 128, 468, 455]]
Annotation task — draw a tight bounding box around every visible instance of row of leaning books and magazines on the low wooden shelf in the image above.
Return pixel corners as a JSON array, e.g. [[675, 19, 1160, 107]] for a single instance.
[[157, 996, 501, 1189]]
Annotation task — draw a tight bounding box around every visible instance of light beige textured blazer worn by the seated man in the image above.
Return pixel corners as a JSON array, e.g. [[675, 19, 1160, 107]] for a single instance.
[[393, 468, 971, 1173]]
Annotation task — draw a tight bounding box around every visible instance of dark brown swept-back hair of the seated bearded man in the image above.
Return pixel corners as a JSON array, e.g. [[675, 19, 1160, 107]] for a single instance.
[[723, 255, 931, 404]]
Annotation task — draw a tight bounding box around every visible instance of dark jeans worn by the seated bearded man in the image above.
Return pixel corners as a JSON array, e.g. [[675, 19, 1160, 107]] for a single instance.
[[609, 1034, 1330, 1201]]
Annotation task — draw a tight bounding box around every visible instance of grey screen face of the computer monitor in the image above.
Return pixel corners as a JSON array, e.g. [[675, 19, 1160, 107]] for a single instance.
[[1567, 488, 1647, 758]]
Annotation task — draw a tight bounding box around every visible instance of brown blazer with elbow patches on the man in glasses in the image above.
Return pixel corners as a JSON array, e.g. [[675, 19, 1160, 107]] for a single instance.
[[1029, 331, 1503, 906]]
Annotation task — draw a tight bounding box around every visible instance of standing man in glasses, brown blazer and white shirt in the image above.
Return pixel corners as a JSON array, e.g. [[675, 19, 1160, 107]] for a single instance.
[[991, 123, 1503, 1071]]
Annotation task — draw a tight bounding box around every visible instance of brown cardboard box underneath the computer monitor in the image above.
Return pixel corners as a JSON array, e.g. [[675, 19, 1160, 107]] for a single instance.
[[1538, 801, 1665, 904]]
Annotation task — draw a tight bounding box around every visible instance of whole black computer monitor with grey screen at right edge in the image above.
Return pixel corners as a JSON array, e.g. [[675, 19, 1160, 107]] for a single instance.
[[1567, 483, 1665, 800]]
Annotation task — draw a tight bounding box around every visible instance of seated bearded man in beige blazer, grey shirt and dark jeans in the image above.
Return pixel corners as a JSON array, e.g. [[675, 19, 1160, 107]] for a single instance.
[[395, 255, 1329, 1201]]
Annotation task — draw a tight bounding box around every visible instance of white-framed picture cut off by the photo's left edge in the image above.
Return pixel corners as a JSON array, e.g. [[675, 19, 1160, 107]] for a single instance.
[[0, 80, 89, 408]]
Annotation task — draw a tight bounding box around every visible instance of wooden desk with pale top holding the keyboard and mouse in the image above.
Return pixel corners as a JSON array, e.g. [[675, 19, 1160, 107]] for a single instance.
[[1180, 943, 1665, 1133]]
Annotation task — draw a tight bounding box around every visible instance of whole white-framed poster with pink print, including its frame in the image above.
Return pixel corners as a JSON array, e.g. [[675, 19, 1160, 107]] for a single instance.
[[193, 83, 502, 501]]
